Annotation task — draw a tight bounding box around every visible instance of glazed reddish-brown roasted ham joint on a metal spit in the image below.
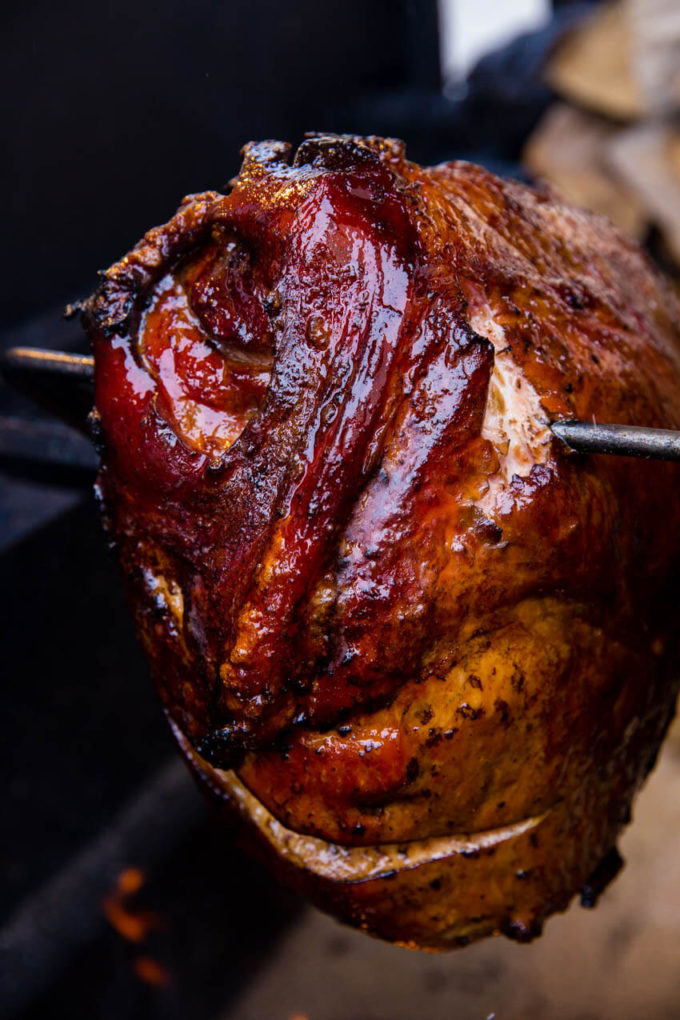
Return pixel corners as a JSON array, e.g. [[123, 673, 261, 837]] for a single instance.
[[85, 136, 680, 948]]
